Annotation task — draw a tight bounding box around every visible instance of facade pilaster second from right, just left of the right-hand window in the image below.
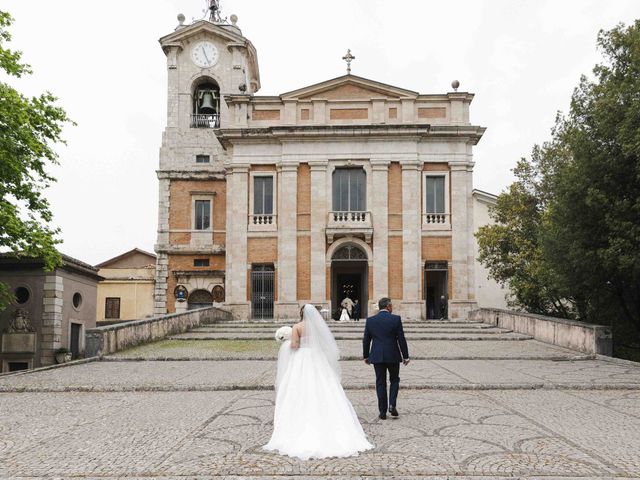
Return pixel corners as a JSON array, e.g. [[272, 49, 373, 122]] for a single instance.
[[401, 160, 422, 319]]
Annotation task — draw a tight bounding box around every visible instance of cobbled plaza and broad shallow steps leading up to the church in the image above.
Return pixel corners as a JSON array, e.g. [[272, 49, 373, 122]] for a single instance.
[[0, 323, 640, 480]]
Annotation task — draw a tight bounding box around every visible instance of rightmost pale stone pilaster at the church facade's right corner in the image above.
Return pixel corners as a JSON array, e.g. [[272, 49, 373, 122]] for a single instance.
[[449, 162, 475, 319]]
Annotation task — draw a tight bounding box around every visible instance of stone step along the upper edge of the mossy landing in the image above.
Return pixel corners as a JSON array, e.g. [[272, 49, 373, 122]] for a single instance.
[[168, 332, 532, 341]]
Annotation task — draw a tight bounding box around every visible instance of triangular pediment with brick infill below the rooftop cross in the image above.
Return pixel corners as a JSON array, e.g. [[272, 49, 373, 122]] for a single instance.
[[280, 75, 418, 101]]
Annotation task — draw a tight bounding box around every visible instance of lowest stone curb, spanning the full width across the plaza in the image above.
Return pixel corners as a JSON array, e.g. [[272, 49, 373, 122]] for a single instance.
[[0, 383, 640, 395]]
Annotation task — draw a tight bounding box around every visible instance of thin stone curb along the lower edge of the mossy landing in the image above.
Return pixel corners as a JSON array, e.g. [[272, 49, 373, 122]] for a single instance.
[[101, 354, 595, 362]]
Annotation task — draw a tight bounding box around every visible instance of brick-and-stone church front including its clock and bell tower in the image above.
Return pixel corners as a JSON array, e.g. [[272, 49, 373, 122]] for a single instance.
[[155, 16, 496, 319]]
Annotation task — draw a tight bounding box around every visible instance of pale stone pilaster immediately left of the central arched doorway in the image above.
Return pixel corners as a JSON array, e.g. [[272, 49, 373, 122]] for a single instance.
[[309, 160, 329, 307]]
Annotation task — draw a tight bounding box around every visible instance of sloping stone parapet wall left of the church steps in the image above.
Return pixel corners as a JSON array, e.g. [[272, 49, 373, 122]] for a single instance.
[[85, 307, 232, 358]]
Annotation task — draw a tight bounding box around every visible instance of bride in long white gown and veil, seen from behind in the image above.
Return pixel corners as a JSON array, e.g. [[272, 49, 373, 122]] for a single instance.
[[263, 304, 373, 460]]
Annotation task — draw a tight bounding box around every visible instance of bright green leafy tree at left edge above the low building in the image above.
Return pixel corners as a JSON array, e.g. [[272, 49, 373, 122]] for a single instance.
[[0, 11, 70, 310]]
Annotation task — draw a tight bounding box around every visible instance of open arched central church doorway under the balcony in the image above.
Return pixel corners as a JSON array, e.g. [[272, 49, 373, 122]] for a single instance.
[[331, 245, 369, 320]]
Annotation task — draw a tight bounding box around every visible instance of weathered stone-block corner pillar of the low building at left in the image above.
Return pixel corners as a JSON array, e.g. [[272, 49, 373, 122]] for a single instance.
[[40, 273, 64, 366]]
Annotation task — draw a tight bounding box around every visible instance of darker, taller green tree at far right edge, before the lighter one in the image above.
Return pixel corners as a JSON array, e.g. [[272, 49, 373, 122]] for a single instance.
[[544, 21, 640, 338]]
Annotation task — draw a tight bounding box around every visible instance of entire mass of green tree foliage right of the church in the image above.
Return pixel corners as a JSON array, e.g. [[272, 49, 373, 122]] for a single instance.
[[477, 21, 640, 348]]
